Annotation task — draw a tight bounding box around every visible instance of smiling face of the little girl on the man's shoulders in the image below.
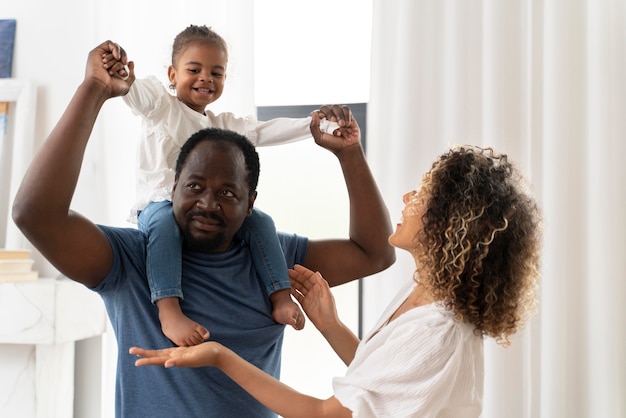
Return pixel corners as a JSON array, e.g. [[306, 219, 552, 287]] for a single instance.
[[167, 42, 227, 114]]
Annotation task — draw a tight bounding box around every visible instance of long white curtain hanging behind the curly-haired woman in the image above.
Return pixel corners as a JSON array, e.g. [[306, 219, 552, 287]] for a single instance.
[[364, 0, 626, 418]]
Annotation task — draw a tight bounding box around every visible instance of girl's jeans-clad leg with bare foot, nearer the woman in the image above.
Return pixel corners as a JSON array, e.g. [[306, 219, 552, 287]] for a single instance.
[[239, 209, 304, 329]]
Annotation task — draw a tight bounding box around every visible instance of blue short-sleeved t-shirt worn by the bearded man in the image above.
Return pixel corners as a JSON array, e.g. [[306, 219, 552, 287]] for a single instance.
[[93, 226, 308, 418]]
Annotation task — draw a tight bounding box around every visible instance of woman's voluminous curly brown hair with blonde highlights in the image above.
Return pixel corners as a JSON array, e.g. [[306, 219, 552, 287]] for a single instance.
[[416, 146, 541, 346]]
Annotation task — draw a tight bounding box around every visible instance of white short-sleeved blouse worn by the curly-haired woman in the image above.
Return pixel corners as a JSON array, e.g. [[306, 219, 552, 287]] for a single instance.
[[333, 283, 484, 418]]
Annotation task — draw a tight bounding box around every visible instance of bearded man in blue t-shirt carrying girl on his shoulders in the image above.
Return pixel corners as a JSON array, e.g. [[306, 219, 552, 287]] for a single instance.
[[13, 42, 395, 418]]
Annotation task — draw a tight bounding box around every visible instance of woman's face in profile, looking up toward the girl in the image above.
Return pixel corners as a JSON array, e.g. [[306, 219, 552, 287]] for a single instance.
[[389, 190, 426, 253]]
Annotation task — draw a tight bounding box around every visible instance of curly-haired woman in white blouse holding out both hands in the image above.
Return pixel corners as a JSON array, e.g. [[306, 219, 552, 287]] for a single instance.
[[130, 146, 541, 418]]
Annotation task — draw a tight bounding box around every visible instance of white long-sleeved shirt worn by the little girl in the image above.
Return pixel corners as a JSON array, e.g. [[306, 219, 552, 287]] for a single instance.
[[122, 76, 328, 222]]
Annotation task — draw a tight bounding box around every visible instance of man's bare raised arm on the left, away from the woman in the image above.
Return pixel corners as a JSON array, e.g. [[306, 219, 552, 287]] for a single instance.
[[12, 41, 133, 286]]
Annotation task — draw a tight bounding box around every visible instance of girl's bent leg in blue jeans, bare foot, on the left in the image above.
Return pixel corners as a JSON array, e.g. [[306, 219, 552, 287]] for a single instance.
[[138, 201, 209, 346]]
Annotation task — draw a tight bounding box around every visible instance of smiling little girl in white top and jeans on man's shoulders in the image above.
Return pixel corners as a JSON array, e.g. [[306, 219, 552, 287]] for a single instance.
[[103, 25, 337, 346]]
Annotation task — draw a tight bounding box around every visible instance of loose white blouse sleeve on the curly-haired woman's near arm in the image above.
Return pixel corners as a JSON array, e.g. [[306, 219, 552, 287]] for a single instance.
[[333, 311, 464, 417]]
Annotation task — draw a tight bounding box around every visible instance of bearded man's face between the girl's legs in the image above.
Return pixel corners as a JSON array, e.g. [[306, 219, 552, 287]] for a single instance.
[[172, 141, 256, 252]]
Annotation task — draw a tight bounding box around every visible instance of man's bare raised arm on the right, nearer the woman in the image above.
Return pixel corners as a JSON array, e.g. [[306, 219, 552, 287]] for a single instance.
[[304, 105, 395, 286]]
